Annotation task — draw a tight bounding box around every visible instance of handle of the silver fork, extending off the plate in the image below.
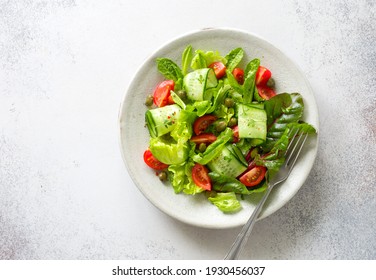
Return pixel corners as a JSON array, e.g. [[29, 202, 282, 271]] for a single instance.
[[224, 186, 273, 260]]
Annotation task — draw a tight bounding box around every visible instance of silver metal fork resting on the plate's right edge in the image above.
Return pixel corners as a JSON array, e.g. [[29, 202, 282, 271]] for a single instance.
[[224, 130, 308, 260]]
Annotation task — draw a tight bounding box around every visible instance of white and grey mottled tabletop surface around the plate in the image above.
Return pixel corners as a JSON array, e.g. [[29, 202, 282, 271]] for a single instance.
[[0, 0, 376, 259]]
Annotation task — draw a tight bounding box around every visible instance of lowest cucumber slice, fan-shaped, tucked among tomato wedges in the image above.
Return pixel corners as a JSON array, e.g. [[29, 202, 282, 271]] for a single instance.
[[207, 145, 247, 178]]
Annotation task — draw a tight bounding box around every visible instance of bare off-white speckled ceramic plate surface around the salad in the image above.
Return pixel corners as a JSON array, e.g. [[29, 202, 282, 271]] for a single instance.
[[119, 29, 319, 229]]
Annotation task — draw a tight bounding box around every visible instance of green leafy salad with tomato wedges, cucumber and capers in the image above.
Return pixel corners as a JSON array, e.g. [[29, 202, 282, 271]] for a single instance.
[[143, 45, 316, 213]]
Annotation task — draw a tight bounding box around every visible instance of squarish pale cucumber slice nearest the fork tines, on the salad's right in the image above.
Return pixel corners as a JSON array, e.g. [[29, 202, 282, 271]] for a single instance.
[[237, 104, 267, 141]]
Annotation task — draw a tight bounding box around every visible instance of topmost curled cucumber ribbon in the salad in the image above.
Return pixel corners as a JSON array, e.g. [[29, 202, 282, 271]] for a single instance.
[[183, 68, 218, 101]]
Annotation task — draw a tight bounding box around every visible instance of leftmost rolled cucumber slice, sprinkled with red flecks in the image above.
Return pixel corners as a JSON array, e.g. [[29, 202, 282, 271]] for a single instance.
[[145, 104, 181, 137]]
